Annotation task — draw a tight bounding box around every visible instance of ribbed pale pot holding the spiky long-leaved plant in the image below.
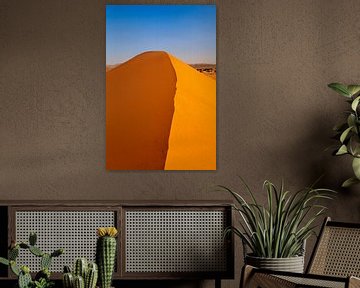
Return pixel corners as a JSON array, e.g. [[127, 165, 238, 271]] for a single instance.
[[245, 255, 304, 273]]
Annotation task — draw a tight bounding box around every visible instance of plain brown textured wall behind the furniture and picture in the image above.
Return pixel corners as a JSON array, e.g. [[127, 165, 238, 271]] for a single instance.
[[0, 0, 360, 287]]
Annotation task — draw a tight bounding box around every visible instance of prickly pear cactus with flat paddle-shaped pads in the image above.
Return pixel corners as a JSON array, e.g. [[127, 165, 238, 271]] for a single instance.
[[0, 233, 64, 288]]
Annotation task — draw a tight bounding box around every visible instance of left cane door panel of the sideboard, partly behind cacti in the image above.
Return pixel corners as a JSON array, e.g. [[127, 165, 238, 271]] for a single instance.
[[11, 208, 117, 273]]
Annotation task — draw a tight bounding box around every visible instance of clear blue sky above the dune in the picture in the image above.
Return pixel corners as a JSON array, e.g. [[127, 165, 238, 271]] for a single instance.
[[106, 5, 216, 65]]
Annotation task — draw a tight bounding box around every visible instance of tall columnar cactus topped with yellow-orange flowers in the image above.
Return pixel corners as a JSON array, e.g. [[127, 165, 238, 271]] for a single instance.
[[96, 227, 117, 288]]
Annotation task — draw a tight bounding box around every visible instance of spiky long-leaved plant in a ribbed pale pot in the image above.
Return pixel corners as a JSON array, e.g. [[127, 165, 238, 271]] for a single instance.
[[220, 180, 334, 273]]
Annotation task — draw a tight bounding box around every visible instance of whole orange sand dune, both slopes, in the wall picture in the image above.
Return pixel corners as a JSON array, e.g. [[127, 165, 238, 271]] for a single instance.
[[106, 52, 216, 170]]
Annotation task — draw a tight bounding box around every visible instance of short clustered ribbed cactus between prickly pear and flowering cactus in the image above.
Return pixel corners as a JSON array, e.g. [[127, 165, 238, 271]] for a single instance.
[[63, 258, 98, 288]]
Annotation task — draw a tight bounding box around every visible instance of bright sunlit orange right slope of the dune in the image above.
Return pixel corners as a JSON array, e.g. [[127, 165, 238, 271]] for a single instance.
[[165, 55, 216, 170]]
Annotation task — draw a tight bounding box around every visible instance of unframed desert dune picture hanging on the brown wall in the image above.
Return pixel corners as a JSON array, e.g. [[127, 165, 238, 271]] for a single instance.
[[106, 5, 216, 170]]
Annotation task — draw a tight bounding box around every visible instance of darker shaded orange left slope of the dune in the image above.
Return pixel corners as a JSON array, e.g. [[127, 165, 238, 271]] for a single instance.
[[106, 51, 176, 170]]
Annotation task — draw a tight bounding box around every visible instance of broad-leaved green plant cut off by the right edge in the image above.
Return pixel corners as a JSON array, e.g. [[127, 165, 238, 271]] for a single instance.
[[328, 83, 360, 187]]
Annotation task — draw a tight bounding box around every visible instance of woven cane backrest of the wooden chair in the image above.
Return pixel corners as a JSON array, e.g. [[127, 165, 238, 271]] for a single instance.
[[307, 218, 360, 277]]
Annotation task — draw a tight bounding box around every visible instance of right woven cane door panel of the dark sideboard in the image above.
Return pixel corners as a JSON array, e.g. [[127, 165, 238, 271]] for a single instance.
[[123, 207, 230, 277]]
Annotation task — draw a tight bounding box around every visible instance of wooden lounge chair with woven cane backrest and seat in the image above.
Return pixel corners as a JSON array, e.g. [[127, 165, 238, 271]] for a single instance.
[[240, 218, 360, 288]]
